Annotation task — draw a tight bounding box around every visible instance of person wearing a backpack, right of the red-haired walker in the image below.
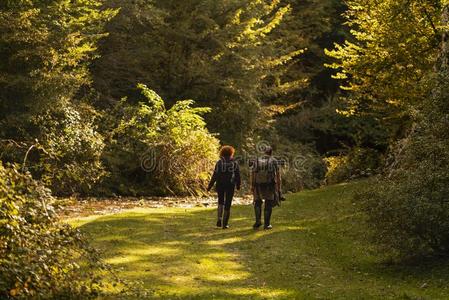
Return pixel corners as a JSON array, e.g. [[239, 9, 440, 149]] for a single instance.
[[251, 148, 281, 229]]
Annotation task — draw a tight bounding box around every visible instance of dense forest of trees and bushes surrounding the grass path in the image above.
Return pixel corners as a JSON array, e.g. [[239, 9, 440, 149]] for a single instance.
[[0, 0, 449, 298]]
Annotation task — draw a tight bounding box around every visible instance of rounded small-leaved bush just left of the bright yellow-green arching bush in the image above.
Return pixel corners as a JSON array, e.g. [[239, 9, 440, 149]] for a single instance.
[[36, 107, 106, 195]]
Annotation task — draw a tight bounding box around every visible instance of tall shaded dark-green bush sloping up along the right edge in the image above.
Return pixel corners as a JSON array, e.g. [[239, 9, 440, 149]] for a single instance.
[[356, 72, 449, 256]]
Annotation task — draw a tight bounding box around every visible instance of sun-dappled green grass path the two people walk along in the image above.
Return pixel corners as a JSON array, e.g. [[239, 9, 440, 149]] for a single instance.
[[72, 182, 449, 299]]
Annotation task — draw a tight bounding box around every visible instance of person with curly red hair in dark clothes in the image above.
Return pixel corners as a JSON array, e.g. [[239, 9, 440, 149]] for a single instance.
[[207, 146, 241, 229]]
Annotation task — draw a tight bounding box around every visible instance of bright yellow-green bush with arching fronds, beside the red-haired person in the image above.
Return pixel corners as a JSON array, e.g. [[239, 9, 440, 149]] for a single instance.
[[104, 85, 218, 195]]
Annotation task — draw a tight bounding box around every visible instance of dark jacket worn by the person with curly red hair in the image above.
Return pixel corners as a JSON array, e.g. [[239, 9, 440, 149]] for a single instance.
[[208, 158, 242, 190]]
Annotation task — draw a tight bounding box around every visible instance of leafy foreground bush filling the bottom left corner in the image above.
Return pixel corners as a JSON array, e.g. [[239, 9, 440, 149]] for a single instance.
[[0, 164, 110, 299]]
